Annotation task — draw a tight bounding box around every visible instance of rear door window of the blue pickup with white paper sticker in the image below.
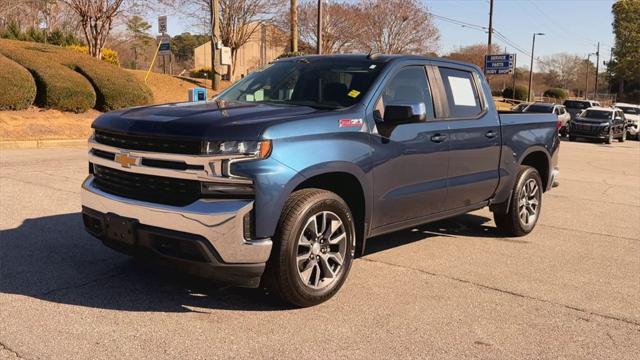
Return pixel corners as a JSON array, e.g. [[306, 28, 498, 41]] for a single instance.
[[439, 67, 483, 118]]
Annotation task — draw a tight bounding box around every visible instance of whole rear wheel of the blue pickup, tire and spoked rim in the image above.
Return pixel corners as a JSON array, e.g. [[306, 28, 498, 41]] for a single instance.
[[493, 166, 542, 236]]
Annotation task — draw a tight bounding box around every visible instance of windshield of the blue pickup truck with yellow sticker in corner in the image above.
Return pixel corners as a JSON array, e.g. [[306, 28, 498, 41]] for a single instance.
[[218, 58, 385, 109]]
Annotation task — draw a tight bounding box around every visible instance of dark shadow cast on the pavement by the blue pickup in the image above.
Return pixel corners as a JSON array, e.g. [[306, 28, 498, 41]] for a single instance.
[[0, 213, 512, 312]]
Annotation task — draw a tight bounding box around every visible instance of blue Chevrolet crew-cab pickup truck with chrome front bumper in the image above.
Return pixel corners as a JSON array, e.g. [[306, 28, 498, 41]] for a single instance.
[[82, 55, 560, 306]]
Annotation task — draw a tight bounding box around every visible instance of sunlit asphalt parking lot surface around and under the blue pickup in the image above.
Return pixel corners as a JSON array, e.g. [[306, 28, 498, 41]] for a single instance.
[[0, 141, 640, 359]]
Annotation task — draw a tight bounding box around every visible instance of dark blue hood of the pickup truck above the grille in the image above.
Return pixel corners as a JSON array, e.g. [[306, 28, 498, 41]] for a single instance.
[[92, 101, 326, 140]]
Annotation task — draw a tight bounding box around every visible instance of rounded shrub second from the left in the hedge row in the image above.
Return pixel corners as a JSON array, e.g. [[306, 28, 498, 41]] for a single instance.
[[0, 40, 96, 112]]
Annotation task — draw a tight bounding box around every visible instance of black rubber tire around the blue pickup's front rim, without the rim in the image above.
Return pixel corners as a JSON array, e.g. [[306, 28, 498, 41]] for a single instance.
[[263, 189, 356, 307]]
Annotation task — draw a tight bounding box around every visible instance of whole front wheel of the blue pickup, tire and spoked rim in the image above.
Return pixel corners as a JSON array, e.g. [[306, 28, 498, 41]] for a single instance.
[[264, 189, 355, 307]]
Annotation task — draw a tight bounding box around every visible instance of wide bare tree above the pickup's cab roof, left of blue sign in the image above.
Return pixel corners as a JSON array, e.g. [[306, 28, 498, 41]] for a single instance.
[[356, 0, 440, 54]]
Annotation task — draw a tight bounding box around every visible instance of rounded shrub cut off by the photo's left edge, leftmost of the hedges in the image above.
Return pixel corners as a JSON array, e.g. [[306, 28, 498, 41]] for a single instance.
[[0, 55, 36, 110]]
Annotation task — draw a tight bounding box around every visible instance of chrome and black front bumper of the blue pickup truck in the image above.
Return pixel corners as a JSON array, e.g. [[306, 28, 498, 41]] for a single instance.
[[81, 176, 272, 287]]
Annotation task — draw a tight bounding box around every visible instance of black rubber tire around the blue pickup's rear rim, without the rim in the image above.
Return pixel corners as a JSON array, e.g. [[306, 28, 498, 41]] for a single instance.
[[493, 166, 543, 237]]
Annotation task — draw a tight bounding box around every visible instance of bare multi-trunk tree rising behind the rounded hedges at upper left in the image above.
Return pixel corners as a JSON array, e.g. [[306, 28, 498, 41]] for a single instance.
[[63, 0, 125, 59]]
